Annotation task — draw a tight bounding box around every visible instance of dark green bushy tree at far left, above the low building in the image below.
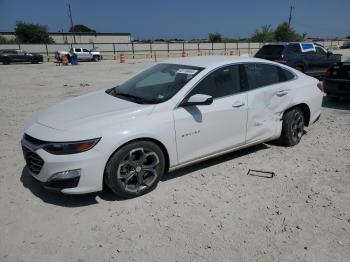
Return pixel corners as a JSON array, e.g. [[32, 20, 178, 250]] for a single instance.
[[15, 22, 54, 44]]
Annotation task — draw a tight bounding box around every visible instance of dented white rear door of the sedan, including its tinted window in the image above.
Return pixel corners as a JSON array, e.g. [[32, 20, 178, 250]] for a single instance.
[[244, 63, 295, 144]]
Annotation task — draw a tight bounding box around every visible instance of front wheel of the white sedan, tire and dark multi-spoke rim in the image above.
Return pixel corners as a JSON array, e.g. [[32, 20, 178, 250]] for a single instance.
[[104, 141, 165, 198]]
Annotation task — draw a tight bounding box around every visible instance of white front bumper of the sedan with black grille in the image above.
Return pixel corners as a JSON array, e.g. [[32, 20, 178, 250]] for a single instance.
[[21, 140, 106, 194]]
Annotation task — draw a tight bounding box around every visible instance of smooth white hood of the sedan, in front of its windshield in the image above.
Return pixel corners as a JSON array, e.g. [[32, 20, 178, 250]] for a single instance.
[[37, 91, 154, 130]]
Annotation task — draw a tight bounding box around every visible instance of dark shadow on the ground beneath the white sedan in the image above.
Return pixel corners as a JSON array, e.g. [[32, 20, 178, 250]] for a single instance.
[[20, 144, 270, 208]]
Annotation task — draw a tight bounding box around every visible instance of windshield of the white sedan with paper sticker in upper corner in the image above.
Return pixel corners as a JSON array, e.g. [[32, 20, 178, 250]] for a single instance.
[[107, 64, 203, 104]]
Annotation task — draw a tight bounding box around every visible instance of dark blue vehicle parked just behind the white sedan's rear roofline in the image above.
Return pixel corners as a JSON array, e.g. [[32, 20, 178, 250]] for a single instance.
[[255, 43, 341, 78]]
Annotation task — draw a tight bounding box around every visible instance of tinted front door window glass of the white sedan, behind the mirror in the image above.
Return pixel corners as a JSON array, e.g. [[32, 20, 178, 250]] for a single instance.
[[188, 65, 241, 98]]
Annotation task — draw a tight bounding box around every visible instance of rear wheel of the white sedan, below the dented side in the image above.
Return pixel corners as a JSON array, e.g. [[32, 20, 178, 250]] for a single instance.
[[278, 107, 305, 146]]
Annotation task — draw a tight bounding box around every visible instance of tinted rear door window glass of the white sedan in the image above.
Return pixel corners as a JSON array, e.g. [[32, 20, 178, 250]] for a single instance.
[[245, 63, 281, 89]]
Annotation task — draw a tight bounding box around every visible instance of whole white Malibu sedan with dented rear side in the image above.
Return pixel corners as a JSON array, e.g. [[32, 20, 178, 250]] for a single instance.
[[22, 56, 323, 198]]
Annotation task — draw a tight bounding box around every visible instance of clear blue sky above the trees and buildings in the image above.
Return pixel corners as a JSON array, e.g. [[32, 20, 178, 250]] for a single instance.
[[0, 0, 350, 40]]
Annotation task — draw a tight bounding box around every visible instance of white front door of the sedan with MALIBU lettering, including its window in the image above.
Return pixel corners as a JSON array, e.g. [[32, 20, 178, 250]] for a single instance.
[[174, 65, 247, 163]]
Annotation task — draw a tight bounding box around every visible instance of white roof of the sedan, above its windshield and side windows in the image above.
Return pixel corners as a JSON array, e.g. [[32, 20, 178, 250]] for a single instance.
[[162, 56, 269, 68]]
